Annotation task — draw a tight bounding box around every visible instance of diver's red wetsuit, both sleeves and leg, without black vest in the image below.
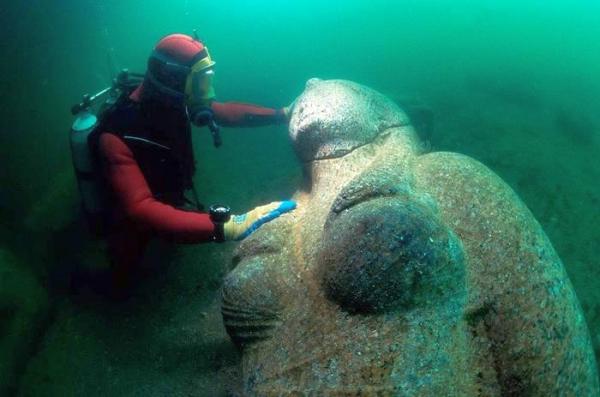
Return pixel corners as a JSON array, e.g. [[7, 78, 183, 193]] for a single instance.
[[98, 92, 285, 287]]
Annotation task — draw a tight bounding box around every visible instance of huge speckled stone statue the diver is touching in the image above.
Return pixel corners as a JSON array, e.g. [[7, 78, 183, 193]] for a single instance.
[[222, 79, 598, 396]]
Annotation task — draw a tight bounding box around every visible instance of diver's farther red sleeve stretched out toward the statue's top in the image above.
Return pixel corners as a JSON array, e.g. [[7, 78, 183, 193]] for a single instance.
[[211, 102, 287, 127]]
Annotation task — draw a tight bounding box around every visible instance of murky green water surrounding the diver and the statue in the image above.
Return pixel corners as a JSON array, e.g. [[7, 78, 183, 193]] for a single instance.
[[0, 0, 600, 395]]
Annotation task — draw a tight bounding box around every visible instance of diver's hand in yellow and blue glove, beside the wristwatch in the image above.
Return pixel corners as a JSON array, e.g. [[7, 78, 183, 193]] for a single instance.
[[223, 201, 296, 240]]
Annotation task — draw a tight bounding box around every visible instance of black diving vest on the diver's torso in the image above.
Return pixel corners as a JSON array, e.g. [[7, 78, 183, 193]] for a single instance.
[[88, 98, 195, 207]]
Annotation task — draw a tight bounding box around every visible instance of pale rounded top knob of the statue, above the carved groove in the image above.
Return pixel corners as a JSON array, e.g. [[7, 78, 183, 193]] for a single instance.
[[290, 79, 409, 161]]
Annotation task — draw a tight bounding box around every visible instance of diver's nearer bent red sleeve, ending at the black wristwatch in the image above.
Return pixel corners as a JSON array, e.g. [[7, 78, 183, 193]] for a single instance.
[[99, 133, 214, 243]]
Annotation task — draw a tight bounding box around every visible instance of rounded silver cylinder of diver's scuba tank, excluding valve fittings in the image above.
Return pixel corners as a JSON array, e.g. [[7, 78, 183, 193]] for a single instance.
[[69, 109, 104, 217]]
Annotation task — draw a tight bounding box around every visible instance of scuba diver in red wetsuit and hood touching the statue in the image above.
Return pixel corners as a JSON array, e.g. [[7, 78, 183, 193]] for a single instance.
[[74, 34, 296, 294]]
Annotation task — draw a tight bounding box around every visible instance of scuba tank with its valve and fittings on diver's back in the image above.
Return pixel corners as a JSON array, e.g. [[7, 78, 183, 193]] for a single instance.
[[69, 69, 143, 236]]
